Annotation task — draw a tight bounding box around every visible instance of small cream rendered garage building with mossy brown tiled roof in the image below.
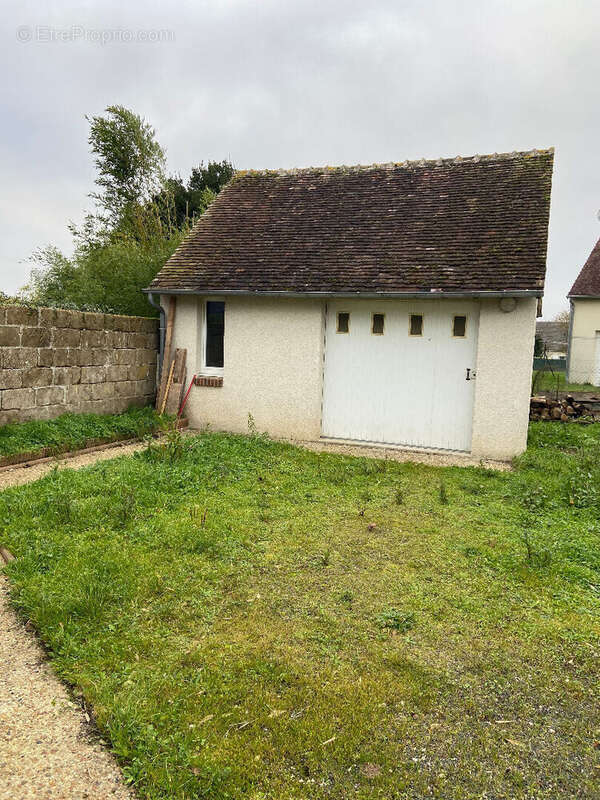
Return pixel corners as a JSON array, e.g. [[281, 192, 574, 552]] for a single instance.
[[146, 150, 553, 459]]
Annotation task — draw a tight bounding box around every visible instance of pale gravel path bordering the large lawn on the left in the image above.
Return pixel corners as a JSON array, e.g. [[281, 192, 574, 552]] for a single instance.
[[0, 443, 144, 800]]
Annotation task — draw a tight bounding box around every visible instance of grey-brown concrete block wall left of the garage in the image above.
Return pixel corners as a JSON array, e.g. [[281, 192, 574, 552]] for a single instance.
[[0, 306, 158, 425]]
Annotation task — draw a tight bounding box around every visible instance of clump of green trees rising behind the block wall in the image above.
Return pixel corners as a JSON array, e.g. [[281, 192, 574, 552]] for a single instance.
[[22, 106, 233, 314]]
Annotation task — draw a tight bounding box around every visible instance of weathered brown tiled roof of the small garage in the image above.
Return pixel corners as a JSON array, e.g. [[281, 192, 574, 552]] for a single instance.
[[149, 149, 554, 295]]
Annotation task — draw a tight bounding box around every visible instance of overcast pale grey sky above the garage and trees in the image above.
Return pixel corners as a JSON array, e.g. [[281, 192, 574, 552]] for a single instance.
[[0, 0, 600, 318]]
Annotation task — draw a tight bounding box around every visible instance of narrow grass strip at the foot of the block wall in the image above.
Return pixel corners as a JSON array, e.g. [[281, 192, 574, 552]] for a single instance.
[[0, 408, 160, 457]]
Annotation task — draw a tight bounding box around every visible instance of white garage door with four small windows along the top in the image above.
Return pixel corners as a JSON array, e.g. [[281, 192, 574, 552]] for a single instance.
[[322, 300, 479, 451]]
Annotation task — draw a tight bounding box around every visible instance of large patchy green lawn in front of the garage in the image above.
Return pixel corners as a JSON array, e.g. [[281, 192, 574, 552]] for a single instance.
[[0, 424, 600, 800]]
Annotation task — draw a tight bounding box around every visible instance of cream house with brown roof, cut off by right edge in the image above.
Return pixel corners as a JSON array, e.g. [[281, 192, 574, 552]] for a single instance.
[[567, 239, 600, 386]]
